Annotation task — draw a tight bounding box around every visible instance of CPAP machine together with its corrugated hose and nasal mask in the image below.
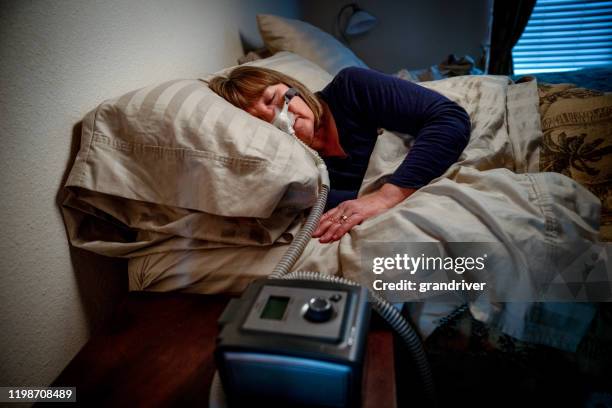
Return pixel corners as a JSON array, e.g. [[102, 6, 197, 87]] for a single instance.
[[209, 88, 435, 408]]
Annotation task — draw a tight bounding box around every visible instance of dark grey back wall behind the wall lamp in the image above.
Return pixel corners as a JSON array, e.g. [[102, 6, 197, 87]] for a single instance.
[[302, 0, 492, 73]]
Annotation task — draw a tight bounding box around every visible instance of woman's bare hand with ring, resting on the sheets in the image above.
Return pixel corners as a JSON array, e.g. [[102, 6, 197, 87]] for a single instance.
[[312, 183, 416, 244]]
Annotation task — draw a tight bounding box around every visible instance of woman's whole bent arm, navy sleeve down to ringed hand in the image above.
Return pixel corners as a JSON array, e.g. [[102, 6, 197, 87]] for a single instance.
[[313, 68, 471, 242]]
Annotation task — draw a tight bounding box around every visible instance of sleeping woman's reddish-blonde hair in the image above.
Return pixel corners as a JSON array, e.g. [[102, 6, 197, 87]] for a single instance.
[[208, 66, 323, 129]]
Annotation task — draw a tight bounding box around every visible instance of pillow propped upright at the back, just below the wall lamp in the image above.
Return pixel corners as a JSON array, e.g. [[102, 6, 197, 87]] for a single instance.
[[257, 14, 368, 75]]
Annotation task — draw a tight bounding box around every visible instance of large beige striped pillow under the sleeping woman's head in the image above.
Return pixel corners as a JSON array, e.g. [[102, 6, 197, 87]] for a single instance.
[[64, 53, 331, 257]]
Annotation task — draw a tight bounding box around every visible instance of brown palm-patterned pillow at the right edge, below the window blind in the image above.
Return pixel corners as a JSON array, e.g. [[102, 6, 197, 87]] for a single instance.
[[538, 84, 612, 241]]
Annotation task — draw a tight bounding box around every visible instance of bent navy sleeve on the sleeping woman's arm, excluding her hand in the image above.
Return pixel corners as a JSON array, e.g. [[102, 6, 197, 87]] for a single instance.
[[346, 68, 471, 188]]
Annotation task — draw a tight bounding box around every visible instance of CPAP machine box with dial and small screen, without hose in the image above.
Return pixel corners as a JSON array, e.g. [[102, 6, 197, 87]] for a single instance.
[[215, 279, 370, 407]]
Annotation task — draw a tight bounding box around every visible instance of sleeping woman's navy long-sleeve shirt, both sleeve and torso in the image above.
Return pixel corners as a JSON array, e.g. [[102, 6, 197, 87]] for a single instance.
[[317, 67, 471, 208]]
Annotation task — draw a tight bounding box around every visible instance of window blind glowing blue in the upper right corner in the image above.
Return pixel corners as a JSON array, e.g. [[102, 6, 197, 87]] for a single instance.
[[512, 0, 612, 74]]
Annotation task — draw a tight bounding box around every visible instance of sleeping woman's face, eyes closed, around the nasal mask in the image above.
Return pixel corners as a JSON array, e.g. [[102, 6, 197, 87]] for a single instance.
[[246, 84, 317, 149]]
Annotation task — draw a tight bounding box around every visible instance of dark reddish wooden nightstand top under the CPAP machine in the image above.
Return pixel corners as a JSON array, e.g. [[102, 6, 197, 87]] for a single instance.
[[52, 292, 396, 408]]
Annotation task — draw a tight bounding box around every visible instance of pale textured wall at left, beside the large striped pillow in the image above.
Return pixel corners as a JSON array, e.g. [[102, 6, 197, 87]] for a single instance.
[[0, 0, 299, 386]]
